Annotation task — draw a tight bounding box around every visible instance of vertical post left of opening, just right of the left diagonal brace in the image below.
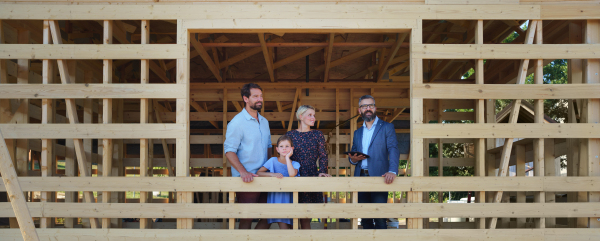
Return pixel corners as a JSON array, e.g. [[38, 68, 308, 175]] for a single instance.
[[102, 20, 113, 229]]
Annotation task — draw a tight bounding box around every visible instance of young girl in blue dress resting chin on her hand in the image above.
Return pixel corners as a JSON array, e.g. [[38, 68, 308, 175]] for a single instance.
[[256, 135, 300, 229]]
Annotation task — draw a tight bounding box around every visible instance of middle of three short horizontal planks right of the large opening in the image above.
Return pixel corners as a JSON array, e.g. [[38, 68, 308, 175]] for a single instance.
[[413, 84, 600, 99]]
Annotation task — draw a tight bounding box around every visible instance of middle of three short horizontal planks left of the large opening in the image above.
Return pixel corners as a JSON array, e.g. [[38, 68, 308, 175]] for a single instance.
[[0, 84, 185, 99]]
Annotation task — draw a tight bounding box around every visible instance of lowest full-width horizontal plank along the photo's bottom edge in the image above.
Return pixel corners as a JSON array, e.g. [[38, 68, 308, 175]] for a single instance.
[[0, 229, 600, 241]]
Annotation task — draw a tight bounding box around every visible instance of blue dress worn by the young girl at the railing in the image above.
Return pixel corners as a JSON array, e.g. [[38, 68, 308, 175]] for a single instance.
[[263, 157, 300, 224]]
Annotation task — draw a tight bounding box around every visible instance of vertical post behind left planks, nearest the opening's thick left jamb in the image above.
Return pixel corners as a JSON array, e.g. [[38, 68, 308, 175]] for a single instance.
[[140, 20, 151, 229]]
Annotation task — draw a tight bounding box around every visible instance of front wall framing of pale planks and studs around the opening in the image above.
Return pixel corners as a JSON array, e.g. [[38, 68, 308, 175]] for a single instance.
[[0, 0, 600, 240]]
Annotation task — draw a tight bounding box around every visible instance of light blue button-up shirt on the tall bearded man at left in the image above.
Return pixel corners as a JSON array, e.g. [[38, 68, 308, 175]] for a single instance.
[[223, 108, 271, 177]]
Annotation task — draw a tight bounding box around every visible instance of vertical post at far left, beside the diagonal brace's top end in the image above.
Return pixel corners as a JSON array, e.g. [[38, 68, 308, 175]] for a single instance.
[[40, 20, 55, 228]]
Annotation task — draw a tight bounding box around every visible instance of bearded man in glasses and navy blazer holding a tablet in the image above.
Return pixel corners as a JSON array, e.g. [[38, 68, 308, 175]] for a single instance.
[[348, 95, 400, 229]]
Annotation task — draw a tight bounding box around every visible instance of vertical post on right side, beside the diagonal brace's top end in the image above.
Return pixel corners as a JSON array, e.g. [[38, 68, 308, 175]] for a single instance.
[[533, 20, 548, 228]]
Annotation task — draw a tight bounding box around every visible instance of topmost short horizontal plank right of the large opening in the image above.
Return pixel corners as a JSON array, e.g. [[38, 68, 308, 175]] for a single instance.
[[412, 44, 600, 60]]
